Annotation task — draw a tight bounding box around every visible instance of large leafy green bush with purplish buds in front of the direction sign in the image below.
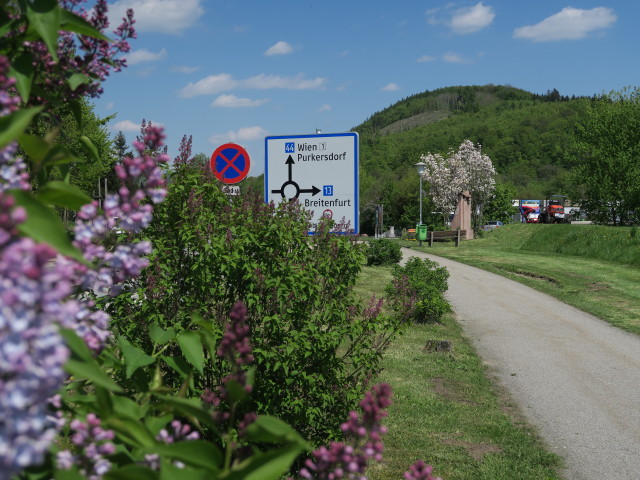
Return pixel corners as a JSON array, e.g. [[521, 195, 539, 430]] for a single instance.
[[106, 165, 400, 442]]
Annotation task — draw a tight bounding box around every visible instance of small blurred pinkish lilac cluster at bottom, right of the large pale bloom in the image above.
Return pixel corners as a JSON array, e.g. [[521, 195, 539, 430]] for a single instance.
[[56, 413, 116, 480]]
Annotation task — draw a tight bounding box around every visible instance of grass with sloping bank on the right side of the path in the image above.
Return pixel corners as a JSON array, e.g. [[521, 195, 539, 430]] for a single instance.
[[398, 224, 640, 334]]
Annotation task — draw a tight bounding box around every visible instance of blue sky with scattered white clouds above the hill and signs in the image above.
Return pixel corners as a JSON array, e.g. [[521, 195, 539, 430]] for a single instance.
[[95, 0, 640, 175]]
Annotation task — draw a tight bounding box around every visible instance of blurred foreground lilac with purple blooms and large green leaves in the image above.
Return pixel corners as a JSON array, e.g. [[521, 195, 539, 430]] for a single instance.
[[0, 0, 444, 480]]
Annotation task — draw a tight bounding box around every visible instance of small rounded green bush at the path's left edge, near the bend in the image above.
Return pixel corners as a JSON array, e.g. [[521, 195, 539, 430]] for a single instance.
[[386, 257, 451, 323]]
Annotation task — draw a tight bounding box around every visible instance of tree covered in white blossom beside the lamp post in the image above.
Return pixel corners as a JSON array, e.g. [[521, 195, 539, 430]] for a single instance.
[[420, 140, 496, 227]]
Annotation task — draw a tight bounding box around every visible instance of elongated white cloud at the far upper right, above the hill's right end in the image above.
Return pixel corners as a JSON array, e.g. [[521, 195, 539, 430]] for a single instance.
[[513, 7, 617, 42]]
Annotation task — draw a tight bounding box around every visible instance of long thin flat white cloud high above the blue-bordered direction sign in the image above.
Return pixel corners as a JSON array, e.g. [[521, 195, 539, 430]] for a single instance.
[[179, 73, 326, 98]]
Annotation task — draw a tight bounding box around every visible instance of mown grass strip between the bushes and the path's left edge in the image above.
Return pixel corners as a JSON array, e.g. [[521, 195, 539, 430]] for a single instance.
[[356, 267, 560, 480]]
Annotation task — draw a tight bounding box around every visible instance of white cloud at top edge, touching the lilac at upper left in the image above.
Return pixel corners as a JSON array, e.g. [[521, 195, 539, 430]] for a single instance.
[[109, 0, 204, 35]]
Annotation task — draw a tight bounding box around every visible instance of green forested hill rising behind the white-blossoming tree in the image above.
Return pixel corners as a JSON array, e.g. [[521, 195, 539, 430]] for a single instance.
[[353, 85, 591, 234]]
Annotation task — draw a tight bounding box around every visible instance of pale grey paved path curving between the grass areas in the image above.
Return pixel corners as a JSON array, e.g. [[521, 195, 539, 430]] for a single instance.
[[403, 249, 640, 480]]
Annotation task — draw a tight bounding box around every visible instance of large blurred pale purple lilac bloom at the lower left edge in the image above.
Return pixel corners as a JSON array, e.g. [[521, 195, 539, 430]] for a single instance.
[[0, 217, 73, 480]]
